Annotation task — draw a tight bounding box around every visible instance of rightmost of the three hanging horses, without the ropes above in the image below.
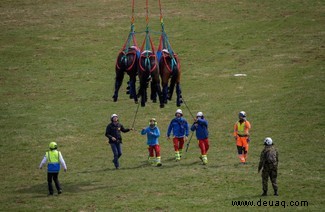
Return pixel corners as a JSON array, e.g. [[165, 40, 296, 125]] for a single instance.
[[159, 49, 183, 107]]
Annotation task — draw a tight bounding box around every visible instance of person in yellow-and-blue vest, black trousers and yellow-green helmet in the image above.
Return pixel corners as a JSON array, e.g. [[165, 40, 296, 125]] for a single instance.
[[39, 142, 67, 195]]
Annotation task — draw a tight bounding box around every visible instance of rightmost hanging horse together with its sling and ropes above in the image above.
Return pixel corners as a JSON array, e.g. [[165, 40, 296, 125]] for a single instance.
[[157, 0, 182, 107]]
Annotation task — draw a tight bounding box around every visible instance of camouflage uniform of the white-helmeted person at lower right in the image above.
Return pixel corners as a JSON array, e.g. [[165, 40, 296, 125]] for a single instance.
[[258, 145, 279, 195]]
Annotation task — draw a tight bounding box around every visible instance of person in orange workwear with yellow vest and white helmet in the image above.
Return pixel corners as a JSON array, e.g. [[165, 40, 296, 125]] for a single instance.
[[234, 111, 251, 164]]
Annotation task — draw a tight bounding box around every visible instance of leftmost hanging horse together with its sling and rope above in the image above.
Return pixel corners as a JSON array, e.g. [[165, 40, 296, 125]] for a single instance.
[[112, 2, 140, 103]]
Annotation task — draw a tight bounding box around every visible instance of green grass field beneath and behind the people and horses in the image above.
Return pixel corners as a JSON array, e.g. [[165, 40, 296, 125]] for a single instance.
[[0, 0, 325, 211]]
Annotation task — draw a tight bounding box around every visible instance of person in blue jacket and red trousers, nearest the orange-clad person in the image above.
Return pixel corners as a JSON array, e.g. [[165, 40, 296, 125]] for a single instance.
[[191, 112, 209, 165]]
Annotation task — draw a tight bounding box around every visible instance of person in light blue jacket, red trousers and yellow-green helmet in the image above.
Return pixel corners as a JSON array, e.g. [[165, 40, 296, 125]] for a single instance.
[[141, 118, 162, 166]]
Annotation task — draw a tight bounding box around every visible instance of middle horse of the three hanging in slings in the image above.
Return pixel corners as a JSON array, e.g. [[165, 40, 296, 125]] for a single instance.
[[138, 50, 164, 108]]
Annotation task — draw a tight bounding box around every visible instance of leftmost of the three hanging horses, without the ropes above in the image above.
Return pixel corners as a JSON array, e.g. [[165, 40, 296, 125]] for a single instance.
[[112, 46, 140, 104]]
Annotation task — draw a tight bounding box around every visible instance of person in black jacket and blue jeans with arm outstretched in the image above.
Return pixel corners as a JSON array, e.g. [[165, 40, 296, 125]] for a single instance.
[[105, 113, 134, 169]]
